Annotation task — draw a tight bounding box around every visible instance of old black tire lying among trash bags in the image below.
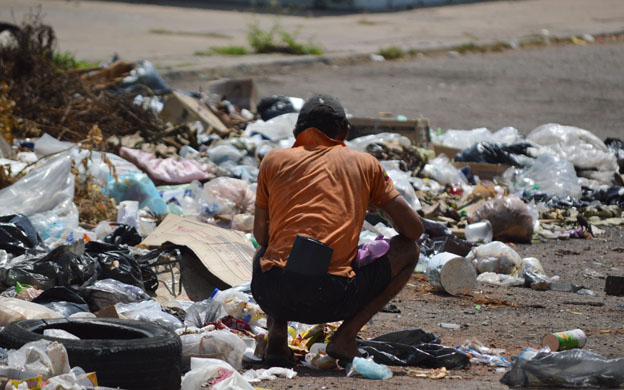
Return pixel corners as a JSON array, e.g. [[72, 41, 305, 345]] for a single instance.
[[0, 318, 182, 390]]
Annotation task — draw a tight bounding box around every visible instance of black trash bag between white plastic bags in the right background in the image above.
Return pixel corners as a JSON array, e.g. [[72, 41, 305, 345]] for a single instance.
[[454, 142, 531, 166]]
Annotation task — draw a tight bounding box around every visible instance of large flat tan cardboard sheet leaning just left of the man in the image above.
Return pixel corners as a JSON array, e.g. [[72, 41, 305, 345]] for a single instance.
[[141, 214, 255, 286]]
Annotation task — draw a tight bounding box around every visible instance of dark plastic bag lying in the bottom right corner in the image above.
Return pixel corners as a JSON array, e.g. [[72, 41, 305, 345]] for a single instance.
[[501, 348, 624, 388]]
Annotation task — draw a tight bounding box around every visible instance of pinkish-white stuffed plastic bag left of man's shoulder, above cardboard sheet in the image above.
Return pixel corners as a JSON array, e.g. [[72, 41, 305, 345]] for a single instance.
[[201, 177, 256, 214]]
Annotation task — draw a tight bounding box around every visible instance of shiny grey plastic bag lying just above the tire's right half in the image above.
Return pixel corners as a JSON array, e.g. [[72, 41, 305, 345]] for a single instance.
[[80, 279, 151, 311]]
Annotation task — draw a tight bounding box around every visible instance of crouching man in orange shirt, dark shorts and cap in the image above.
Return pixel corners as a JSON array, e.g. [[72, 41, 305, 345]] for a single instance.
[[251, 95, 423, 366]]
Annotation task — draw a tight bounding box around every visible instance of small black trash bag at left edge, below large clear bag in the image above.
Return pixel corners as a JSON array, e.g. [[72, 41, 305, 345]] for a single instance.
[[0, 214, 39, 256]]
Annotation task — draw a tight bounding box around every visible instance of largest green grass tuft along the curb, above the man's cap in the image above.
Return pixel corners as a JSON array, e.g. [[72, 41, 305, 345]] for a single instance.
[[247, 23, 323, 55]]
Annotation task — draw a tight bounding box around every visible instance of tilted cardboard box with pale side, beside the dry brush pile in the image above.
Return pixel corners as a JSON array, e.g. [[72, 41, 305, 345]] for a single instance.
[[160, 91, 229, 135]]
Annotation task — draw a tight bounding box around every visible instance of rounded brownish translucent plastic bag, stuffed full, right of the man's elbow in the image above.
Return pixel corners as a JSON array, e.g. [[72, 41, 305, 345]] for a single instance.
[[470, 195, 533, 242]]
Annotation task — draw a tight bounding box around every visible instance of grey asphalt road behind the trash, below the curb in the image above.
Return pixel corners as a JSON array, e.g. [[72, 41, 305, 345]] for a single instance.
[[171, 39, 624, 139]]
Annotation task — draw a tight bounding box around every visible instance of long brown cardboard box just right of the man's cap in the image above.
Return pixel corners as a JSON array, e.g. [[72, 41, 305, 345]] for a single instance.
[[348, 117, 431, 145]]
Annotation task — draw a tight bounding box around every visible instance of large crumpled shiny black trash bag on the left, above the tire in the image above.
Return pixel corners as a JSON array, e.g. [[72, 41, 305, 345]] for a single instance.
[[6, 240, 101, 290]]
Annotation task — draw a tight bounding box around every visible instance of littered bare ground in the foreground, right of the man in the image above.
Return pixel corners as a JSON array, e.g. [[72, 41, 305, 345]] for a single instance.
[[243, 228, 624, 390]]
